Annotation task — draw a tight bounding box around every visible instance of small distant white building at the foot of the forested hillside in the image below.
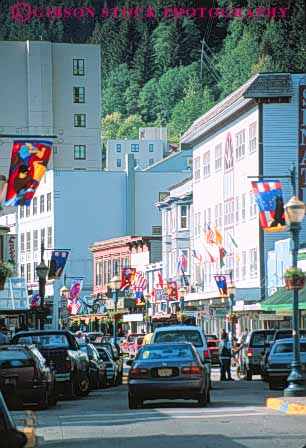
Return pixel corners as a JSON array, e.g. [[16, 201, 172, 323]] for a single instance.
[[106, 128, 168, 171]]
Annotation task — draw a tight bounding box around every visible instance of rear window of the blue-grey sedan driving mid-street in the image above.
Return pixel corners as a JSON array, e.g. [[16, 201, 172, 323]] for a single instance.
[[138, 345, 194, 360]]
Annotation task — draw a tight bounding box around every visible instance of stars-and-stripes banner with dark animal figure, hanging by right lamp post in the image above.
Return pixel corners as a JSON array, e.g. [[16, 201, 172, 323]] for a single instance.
[[252, 180, 286, 232]]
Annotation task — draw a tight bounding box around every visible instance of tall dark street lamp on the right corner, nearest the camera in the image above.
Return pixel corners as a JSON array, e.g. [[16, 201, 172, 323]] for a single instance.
[[284, 196, 306, 397]]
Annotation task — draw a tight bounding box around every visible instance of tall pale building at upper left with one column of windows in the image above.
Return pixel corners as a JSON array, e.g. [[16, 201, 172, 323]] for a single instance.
[[0, 41, 102, 173]]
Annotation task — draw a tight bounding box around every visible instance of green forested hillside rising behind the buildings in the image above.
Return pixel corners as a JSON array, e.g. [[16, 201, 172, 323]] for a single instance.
[[0, 0, 306, 142]]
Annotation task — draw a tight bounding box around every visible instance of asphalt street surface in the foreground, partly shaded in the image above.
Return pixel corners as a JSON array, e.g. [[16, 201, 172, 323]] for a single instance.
[[36, 372, 306, 448]]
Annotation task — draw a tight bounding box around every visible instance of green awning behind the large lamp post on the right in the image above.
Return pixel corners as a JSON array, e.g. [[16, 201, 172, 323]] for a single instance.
[[261, 286, 306, 311]]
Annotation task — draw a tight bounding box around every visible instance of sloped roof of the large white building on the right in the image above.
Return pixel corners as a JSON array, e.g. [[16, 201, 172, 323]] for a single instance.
[[180, 73, 292, 144]]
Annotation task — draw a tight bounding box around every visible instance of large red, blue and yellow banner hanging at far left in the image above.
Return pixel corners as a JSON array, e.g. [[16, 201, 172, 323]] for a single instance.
[[4, 140, 52, 206]]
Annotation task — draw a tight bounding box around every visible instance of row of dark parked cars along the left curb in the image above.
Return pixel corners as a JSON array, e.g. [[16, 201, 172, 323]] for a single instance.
[[0, 330, 123, 409]]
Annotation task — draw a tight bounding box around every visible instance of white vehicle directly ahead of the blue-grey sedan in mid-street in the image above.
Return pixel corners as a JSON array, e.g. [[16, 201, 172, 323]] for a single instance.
[[152, 325, 211, 384]]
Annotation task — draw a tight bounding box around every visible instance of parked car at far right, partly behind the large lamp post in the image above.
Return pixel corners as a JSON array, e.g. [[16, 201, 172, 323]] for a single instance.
[[267, 338, 306, 389]]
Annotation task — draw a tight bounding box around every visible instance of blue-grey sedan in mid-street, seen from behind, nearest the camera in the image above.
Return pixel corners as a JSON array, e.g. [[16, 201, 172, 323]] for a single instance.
[[128, 342, 210, 409]]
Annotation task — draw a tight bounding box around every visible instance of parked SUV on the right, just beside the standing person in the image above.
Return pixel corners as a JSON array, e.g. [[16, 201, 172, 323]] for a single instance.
[[237, 330, 275, 381]]
